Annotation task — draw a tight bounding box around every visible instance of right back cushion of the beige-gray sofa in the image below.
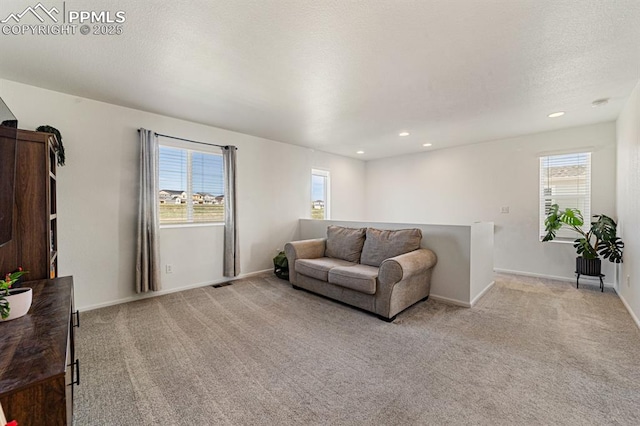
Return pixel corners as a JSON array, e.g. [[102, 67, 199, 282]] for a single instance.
[[360, 228, 422, 266]]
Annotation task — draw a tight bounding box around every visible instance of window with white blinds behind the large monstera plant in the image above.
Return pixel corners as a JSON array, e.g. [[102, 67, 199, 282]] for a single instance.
[[540, 152, 591, 241]]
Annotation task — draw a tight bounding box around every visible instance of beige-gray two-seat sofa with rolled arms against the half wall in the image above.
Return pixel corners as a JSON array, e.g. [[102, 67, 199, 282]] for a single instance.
[[285, 226, 437, 321]]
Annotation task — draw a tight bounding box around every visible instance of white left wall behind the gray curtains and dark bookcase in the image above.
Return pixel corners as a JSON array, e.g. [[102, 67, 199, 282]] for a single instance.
[[0, 80, 365, 309]]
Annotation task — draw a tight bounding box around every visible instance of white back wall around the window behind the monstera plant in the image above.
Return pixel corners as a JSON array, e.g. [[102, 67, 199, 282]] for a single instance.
[[366, 123, 616, 283]]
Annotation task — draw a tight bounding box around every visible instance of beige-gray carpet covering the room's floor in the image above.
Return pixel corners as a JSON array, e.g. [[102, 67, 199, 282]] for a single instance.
[[75, 274, 640, 426]]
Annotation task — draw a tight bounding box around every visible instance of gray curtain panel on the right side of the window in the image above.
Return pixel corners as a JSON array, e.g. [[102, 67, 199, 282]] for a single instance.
[[222, 145, 240, 277]]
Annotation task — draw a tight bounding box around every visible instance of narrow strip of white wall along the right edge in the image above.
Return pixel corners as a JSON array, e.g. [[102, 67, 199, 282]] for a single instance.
[[617, 83, 640, 327]]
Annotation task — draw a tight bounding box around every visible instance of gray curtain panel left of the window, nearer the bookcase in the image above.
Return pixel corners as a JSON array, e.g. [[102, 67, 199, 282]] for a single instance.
[[136, 129, 160, 293]]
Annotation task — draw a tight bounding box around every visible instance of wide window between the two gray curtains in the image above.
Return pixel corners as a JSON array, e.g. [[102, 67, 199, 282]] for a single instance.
[[158, 145, 225, 225]]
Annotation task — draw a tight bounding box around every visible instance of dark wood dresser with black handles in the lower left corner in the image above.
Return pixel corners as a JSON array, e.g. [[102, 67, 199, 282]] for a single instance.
[[0, 277, 79, 426]]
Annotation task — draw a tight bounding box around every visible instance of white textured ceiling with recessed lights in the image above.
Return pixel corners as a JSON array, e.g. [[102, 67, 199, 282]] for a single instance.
[[0, 0, 640, 160]]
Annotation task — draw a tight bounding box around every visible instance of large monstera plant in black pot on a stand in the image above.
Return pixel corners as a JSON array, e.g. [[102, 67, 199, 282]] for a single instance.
[[542, 204, 624, 291]]
